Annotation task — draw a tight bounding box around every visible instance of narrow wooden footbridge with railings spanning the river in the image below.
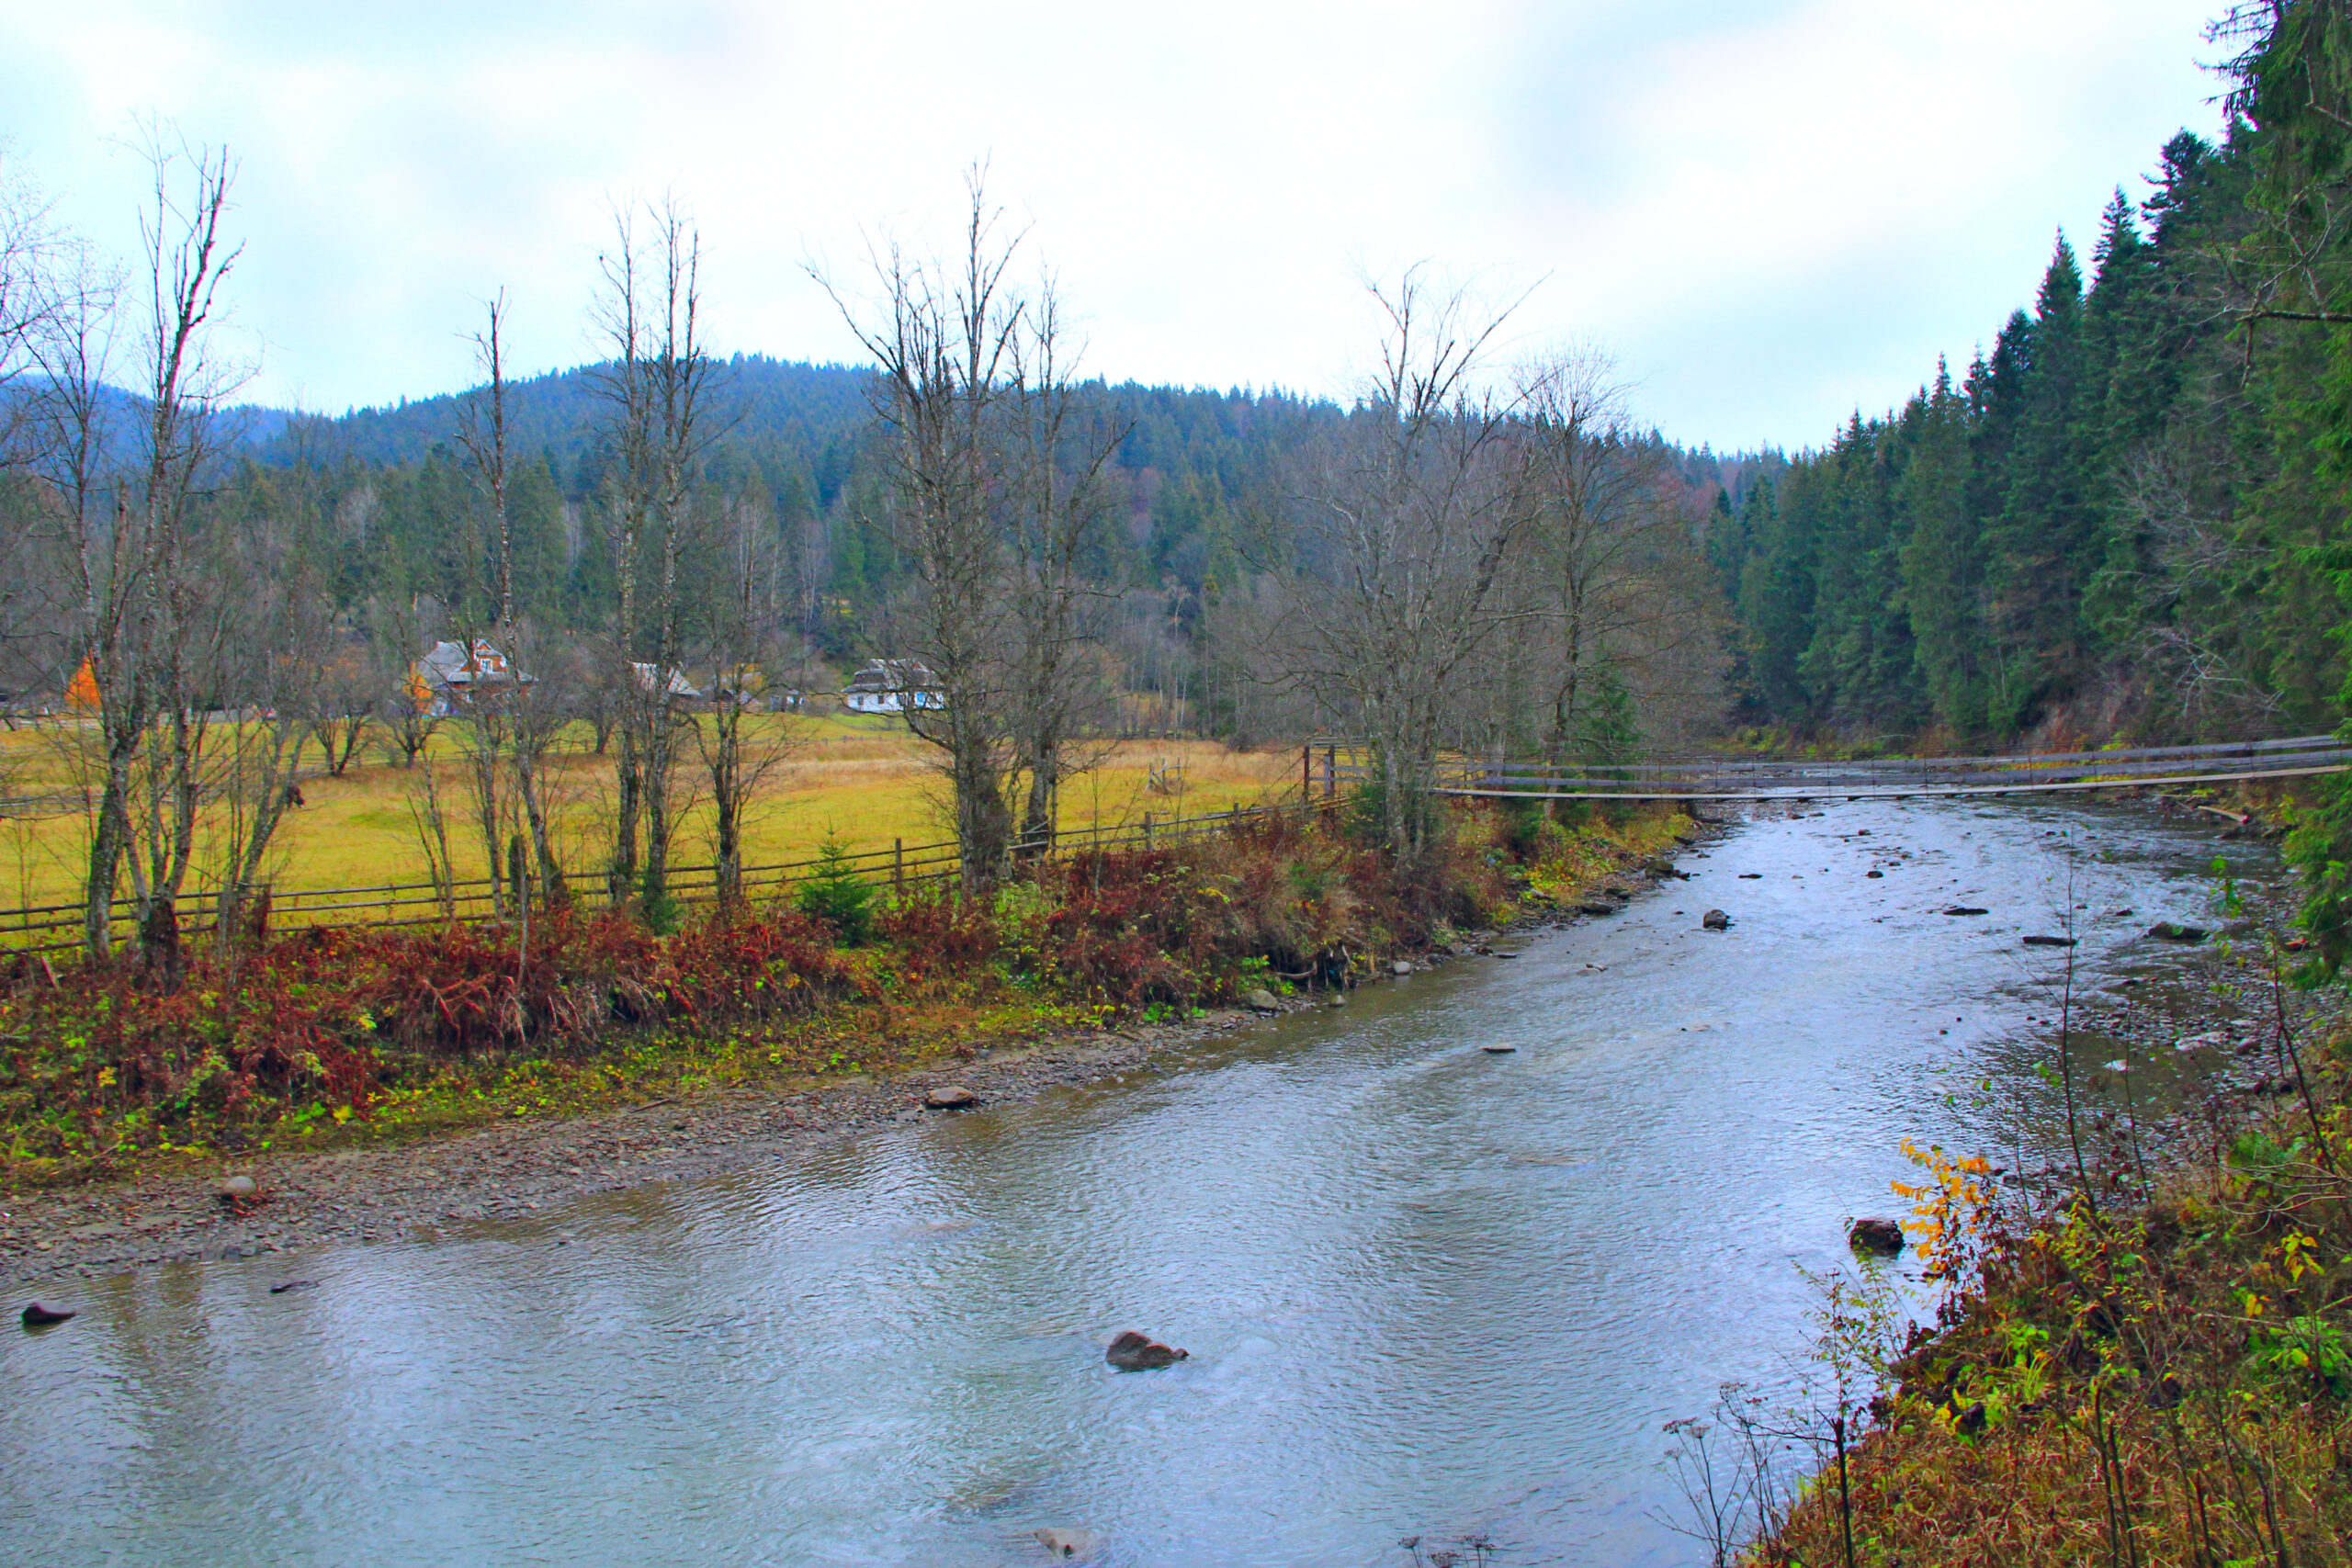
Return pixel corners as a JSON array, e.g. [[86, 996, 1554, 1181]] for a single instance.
[[1301, 736, 2352, 804]]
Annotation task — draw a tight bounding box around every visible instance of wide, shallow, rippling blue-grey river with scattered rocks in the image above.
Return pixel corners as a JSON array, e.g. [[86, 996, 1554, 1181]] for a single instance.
[[0, 802, 2269, 1568]]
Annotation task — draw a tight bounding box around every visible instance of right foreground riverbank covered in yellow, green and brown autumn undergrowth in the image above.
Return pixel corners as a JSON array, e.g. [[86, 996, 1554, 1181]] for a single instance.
[[1740, 879, 2352, 1568]]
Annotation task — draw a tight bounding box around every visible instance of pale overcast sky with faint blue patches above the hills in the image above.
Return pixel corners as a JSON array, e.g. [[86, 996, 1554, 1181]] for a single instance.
[[0, 0, 2218, 449]]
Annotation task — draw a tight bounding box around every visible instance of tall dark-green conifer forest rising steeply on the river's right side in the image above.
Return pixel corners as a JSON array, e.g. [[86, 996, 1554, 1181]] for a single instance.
[[1710, 5, 2352, 740]]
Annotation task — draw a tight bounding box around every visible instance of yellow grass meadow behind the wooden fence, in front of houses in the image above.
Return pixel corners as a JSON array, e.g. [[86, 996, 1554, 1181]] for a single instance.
[[0, 715, 1298, 940]]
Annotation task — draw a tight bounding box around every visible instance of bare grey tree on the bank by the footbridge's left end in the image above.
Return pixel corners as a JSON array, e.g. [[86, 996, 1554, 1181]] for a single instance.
[[1277, 265, 1532, 863]]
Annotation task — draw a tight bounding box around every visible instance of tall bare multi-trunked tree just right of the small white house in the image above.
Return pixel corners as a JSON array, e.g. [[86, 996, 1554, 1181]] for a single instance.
[[819, 167, 1122, 888]]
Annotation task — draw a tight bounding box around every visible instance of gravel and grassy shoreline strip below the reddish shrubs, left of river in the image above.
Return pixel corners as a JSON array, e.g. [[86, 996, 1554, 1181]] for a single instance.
[[0, 811, 1702, 1286]]
